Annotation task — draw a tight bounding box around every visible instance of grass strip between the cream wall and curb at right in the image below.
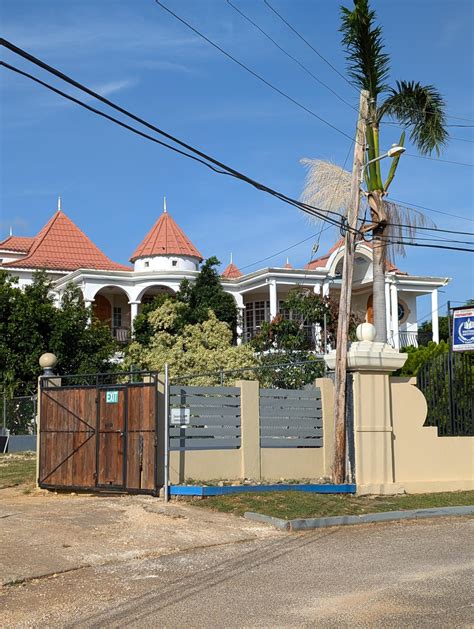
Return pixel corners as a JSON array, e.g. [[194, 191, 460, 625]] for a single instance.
[[193, 491, 474, 520]]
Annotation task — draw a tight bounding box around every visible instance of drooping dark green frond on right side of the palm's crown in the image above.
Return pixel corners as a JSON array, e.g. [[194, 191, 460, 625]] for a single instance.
[[378, 81, 448, 155]]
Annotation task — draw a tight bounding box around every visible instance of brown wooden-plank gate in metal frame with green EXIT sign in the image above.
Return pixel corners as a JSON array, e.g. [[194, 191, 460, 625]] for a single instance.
[[38, 372, 158, 494]]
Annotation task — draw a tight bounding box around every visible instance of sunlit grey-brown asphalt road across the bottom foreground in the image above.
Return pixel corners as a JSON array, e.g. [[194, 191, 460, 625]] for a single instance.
[[2, 518, 474, 627]]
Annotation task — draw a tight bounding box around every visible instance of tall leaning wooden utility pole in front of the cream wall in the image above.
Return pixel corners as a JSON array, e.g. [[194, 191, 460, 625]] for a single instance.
[[333, 90, 369, 483]]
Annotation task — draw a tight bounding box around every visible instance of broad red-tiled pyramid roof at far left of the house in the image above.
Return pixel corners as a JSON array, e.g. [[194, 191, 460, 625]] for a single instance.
[[4, 211, 132, 271]]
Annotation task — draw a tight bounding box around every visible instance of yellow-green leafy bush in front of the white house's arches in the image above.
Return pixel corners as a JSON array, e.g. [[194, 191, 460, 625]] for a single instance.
[[124, 299, 256, 385]]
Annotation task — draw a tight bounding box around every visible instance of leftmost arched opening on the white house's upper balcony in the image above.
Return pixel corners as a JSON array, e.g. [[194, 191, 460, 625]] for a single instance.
[[92, 286, 131, 343]]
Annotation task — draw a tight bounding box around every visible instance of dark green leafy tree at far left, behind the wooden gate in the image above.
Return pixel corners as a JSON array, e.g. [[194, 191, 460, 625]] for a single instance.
[[0, 271, 116, 396]]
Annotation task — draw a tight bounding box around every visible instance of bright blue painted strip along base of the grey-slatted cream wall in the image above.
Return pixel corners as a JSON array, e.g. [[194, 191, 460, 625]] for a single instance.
[[169, 483, 356, 496]]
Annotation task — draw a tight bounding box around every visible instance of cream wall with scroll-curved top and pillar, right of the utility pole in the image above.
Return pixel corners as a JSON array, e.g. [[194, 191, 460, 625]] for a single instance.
[[354, 370, 474, 494]]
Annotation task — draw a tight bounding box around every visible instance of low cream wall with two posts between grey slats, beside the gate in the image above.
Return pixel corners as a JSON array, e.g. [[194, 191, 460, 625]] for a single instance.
[[168, 378, 334, 484]]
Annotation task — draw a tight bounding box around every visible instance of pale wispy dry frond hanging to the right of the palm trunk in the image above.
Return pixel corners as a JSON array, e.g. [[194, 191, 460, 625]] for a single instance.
[[384, 199, 436, 261]]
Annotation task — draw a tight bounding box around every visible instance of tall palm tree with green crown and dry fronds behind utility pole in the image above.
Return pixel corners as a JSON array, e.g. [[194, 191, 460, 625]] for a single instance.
[[302, 0, 448, 341]]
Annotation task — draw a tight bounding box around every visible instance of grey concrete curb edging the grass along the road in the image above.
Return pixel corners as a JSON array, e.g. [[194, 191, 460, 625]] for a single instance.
[[244, 505, 474, 531]]
